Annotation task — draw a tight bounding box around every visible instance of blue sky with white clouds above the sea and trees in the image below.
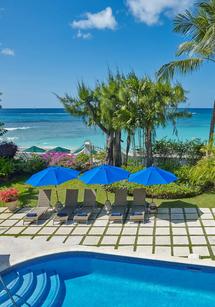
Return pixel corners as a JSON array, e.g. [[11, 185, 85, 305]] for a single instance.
[[0, 0, 215, 108]]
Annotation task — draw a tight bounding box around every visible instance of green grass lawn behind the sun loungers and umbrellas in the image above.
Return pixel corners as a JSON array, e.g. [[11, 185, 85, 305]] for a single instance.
[[0, 178, 215, 208]]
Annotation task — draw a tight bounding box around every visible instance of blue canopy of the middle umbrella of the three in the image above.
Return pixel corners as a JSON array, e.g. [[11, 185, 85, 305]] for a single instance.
[[80, 165, 130, 184]]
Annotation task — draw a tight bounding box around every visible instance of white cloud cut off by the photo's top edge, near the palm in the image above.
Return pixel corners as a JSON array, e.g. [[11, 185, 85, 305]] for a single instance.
[[126, 0, 195, 25]]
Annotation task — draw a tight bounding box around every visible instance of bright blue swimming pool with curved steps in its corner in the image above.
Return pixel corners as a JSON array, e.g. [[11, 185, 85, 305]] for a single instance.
[[0, 252, 215, 307]]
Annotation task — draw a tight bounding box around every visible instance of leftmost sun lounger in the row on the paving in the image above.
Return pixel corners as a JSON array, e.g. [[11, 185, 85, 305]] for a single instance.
[[23, 190, 51, 224]]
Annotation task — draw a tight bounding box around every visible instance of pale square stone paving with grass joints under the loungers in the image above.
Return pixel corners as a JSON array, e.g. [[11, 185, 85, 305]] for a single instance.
[[0, 206, 215, 260]]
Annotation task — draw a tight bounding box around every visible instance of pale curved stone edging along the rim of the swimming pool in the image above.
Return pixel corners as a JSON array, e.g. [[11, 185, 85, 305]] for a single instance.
[[0, 238, 215, 272]]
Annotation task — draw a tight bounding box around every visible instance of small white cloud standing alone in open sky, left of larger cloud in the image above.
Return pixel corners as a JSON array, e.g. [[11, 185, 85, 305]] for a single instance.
[[71, 7, 117, 30]]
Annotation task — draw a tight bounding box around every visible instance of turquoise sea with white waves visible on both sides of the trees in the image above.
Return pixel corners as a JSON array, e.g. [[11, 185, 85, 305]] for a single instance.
[[0, 109, 212, 149]]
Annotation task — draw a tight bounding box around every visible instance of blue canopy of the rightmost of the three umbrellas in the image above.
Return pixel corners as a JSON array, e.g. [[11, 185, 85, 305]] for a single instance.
[[128, 166, 178, 186]]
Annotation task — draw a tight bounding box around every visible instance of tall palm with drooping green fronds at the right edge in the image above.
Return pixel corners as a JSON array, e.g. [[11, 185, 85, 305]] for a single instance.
[[158, 0, 215, 149]]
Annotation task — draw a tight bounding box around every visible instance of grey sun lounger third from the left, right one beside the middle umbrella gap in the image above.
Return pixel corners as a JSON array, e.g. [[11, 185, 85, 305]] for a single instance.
[[73, 189, 96, 223]]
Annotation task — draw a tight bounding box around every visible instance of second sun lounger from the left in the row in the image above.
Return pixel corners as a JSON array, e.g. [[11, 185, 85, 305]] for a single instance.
[[53, 189, 78, 224]]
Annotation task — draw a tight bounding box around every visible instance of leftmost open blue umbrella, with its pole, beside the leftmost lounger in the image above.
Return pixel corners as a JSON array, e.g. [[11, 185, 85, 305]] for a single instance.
[[26, 166, 79, 200]]
